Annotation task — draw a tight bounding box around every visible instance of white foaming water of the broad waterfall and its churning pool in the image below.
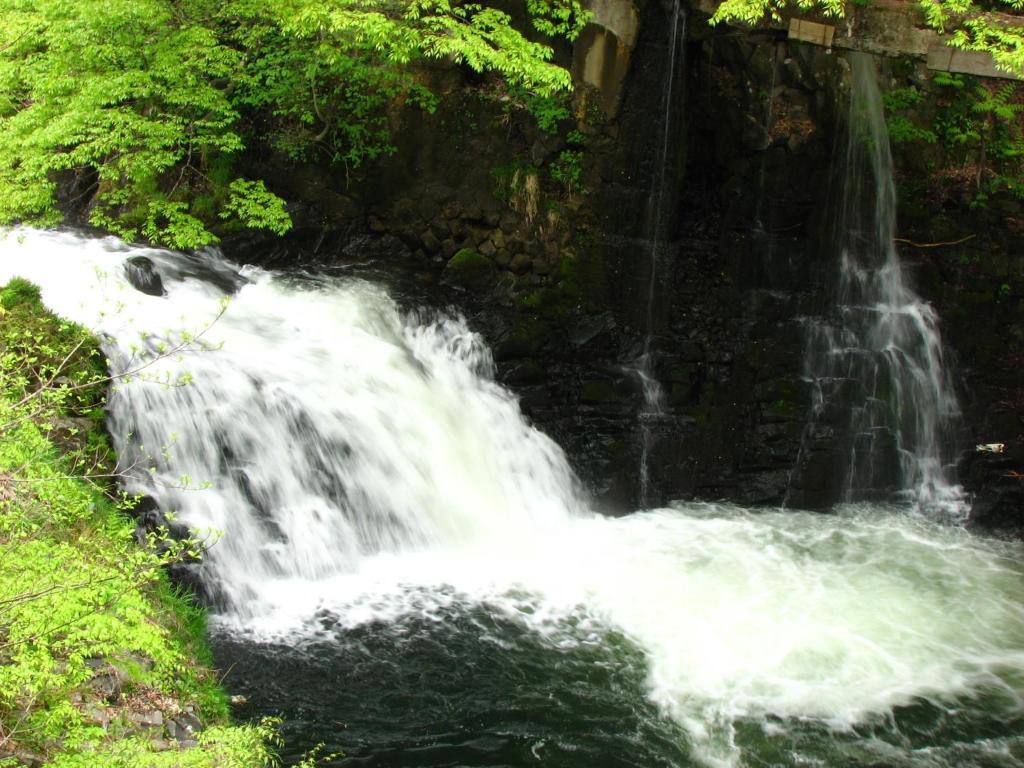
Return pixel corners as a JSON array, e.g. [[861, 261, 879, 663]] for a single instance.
[[0, 231, 1024, 766]]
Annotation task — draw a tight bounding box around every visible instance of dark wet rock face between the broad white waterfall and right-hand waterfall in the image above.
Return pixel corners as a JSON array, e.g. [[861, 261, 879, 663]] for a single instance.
[[234, 24, 847, 511]]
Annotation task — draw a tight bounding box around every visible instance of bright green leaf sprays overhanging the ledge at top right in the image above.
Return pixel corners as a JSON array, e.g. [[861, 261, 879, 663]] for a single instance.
[[711, 0, 1024, 77]]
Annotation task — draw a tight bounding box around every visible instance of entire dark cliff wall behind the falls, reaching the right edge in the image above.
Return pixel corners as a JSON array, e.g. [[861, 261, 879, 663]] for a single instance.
[[232, 2, 1024, 524]]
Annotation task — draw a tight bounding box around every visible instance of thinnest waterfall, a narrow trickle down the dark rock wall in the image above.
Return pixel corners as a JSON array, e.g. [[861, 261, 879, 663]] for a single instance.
[[632, 0, 687, 507]]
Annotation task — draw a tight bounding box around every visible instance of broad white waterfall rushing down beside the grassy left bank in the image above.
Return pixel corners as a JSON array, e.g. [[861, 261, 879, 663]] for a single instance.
[[0, 234, 583, 616]]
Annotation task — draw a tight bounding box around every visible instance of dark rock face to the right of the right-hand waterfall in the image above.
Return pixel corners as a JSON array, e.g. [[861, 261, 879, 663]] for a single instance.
[[901, 210, 1024, 537]]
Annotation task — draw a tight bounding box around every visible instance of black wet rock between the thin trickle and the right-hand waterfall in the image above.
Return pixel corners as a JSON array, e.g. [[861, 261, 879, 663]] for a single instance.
[[609, 27, 836, 506]]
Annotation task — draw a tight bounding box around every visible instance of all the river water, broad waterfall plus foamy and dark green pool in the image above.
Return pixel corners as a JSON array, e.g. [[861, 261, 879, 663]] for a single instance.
[[0, 231, 1024, 767]]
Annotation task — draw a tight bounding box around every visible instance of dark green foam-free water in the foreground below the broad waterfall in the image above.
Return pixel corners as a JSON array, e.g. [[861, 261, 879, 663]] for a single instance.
[[217, 606, 692, 768]]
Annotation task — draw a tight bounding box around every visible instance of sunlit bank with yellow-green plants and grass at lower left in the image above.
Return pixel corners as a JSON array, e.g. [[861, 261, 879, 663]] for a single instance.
[[0, 279, 275, 768]]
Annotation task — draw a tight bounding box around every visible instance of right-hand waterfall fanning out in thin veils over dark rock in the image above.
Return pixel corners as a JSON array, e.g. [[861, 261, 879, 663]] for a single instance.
[[801, 53, 964, 515]]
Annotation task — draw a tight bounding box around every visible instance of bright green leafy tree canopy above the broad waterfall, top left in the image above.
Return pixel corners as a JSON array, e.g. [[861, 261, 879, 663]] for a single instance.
[[0, 0, 586, 248]]
